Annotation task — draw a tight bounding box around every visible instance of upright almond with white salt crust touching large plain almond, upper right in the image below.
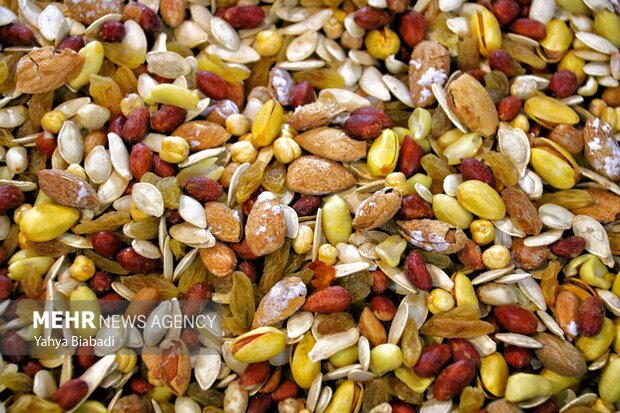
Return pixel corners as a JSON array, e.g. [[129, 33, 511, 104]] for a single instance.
[[409, 40, 450, 108]]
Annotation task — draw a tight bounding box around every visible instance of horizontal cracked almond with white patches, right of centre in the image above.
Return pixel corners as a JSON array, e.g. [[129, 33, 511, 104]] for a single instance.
[[397, 219, 467, 255]]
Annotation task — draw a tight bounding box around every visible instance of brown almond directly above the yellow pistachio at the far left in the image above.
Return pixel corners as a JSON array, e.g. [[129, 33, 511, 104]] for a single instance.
[[37, 169, 99, 209]]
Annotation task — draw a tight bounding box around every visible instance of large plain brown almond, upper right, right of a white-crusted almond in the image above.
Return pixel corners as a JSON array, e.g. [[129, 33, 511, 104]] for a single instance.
[[446, 73, 499, 137]]
